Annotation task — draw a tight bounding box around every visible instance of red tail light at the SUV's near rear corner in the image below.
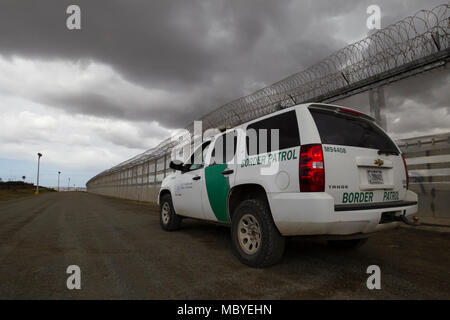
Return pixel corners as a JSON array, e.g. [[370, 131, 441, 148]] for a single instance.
[[299, 144, 325, 192]]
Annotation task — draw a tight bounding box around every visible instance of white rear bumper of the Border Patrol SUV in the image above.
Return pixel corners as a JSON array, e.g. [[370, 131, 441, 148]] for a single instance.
[[268, 190, 417, 236]]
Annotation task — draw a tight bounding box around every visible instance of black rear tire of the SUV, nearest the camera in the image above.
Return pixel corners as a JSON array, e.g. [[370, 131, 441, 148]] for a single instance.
[[231, 199, 285, 268]]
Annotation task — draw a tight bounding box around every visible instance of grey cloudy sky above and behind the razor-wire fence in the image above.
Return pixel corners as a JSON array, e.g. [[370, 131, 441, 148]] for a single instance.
[[0, 0, 450, 186]]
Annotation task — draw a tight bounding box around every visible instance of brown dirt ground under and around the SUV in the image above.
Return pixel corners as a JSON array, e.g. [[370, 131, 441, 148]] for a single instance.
[[0, 192, 450, 299]]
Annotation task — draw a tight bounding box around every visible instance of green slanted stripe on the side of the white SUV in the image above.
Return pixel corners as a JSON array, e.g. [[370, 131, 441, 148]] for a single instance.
[[205, 163, 230, 222]]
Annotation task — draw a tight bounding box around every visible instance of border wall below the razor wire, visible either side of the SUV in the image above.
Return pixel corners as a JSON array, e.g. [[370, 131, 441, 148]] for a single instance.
[[88, 132, 450, 219]]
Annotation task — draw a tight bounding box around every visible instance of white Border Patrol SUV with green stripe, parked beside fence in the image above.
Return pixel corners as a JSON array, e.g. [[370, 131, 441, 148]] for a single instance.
[[158, 104, 417, 267]]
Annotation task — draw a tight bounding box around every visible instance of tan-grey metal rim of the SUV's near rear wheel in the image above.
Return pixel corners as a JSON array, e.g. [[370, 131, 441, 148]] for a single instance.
[[238, 213, 261, 255]]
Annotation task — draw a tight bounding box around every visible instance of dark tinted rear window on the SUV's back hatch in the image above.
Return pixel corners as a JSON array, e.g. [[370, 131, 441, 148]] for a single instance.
[[310, 109, 398, 152]]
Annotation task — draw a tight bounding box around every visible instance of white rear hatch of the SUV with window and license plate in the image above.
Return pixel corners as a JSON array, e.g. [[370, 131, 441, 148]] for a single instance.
[[309, 105, 407, 207]]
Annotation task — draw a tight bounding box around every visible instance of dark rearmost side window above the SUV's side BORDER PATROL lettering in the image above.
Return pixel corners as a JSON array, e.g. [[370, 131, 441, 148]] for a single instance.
[[246, 111, 300, 156]]
